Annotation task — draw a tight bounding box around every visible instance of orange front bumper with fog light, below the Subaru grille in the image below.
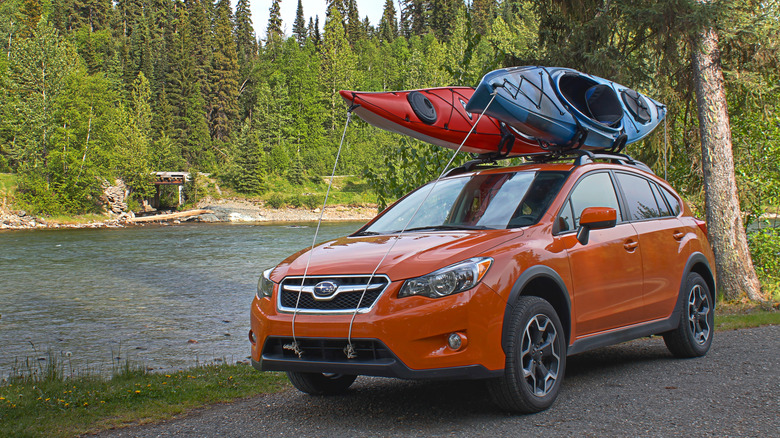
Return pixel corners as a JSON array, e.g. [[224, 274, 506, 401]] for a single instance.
[[250, 283, 506, 379]]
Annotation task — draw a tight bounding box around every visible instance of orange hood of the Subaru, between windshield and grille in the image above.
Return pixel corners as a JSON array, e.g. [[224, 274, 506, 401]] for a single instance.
[[271, 229, 523, 282]]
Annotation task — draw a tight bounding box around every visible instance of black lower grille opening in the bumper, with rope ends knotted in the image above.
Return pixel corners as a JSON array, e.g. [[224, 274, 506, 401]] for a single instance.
[[263, 337, 395, 363]]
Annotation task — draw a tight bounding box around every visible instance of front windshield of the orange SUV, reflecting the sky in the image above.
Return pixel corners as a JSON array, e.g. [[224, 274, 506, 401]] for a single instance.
[[357, 171, 567, 234]]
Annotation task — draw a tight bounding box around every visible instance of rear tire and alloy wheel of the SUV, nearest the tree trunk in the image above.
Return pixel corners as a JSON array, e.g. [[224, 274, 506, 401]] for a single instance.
[[663, 272, 715, 358]]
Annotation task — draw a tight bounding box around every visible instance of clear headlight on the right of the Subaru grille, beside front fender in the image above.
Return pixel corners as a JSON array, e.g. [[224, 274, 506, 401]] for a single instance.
[[398, 257, 493, 298]]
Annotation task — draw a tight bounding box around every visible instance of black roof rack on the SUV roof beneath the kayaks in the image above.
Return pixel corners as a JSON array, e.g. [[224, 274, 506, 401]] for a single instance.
[[445, 149, 655, 177]]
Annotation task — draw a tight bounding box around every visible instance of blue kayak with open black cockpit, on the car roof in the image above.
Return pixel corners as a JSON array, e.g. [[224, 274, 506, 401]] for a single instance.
[[466, 66, 666, 150]]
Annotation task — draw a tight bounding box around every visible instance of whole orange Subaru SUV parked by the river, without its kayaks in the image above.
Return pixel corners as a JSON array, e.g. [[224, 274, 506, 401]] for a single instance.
[[249, 152, 715, 413]]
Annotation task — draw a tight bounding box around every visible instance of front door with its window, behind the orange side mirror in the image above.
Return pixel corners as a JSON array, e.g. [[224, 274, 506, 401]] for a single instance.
[[555, 171, 643, 339]]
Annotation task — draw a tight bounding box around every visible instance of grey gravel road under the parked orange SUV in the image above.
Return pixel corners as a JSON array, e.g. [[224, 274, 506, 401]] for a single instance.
[[99, 326, 780, 437]]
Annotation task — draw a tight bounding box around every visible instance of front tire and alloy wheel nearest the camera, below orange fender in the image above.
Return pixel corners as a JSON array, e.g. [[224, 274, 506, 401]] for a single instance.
[[487, 297, 567, 414]]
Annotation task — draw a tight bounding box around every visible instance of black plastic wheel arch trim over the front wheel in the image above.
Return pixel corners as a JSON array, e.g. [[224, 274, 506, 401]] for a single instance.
[[501, 265, 571, 353]]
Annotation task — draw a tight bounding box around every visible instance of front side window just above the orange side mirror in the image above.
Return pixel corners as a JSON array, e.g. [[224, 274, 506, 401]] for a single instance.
[[558, 172, 624, 231]]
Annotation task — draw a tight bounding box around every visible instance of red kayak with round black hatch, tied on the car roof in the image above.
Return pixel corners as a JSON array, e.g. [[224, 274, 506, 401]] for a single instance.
[[339, 87, 545, 156]]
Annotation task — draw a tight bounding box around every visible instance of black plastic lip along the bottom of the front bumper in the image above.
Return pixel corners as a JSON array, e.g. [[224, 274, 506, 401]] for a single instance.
[[252, 339, 504, 380]]
